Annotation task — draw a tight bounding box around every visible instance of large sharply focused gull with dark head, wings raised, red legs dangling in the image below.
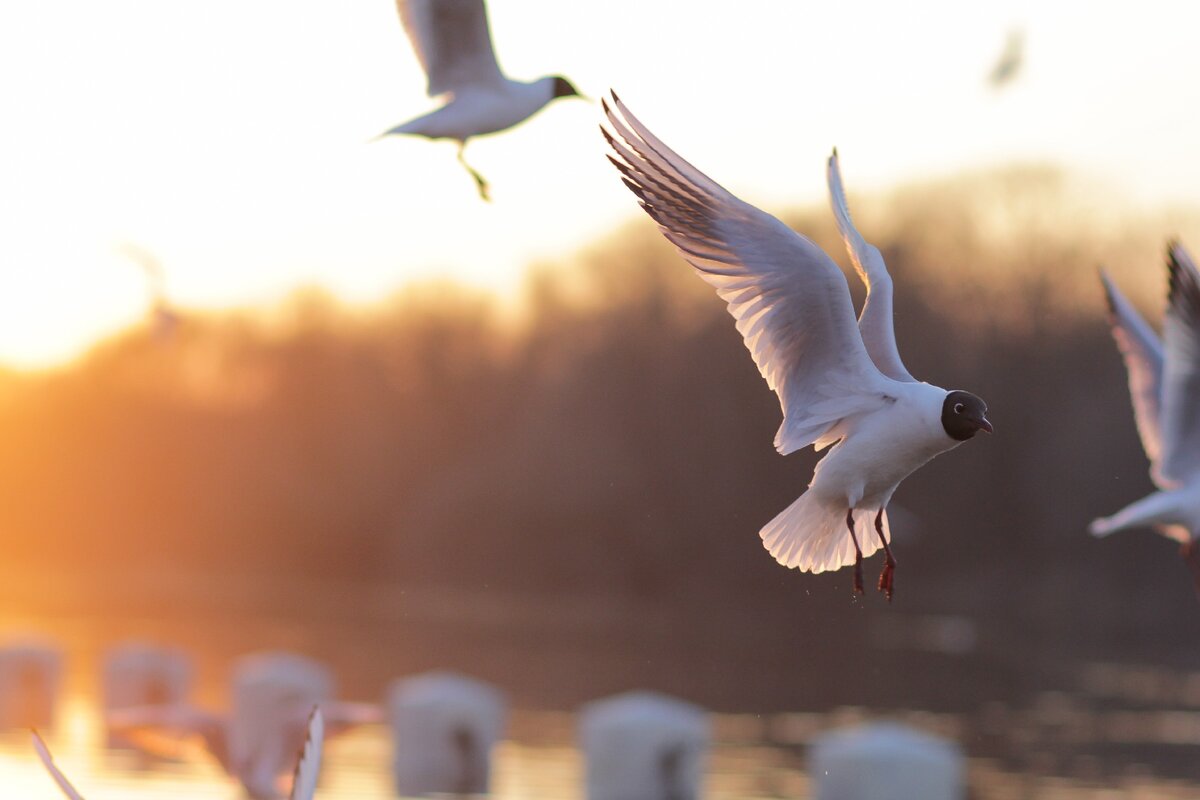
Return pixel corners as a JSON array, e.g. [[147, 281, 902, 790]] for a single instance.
[[601, 94, 991, 600]]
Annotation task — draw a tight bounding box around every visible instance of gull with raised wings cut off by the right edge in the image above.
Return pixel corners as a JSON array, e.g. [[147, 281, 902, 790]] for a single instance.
[[1088, 242, 1200, 591]]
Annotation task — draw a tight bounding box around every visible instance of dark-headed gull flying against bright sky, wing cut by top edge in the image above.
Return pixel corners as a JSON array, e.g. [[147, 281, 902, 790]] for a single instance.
[[383, 0, 580, 200]]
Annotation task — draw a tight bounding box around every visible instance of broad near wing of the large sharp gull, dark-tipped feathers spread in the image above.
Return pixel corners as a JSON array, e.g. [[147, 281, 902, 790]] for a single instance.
[[601, 94, 895, 455]]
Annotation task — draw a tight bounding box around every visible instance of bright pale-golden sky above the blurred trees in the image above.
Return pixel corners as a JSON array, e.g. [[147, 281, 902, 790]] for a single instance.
[[0, 0, 1200, 366]]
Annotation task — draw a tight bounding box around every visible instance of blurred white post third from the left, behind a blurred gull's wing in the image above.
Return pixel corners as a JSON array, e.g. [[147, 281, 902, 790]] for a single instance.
[[229, 652, 334, 775]]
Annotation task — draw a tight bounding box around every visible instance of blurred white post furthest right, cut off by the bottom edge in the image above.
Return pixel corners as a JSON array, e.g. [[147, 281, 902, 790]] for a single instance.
[[809, 722, 966, 800]]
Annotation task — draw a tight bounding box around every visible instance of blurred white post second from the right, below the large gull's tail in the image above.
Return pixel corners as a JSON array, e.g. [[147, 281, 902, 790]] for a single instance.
[[580, 692, 710, 800]]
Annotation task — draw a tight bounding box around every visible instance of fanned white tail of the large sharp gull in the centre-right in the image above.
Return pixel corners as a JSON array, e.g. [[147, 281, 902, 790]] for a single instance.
[[758, 492, 892, 572]]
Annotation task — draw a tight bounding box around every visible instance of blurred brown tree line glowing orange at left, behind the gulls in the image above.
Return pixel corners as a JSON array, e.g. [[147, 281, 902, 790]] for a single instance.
[[0, 167, 1200, 702]]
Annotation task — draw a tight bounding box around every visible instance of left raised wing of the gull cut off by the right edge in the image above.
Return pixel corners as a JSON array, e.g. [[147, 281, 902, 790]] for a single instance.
[[1100, 270, 1171, 488]]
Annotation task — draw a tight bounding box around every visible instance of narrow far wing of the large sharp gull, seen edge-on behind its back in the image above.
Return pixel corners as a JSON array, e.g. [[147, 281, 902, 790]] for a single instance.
[[827, 150, 917, 383]]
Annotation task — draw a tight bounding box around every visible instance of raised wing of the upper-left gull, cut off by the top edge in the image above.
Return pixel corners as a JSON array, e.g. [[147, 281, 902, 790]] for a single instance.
[[396, 0, 504, 97]]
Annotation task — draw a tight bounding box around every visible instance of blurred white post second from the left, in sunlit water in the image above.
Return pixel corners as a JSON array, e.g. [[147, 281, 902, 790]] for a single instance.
[[103, 642, 193, 712]]
